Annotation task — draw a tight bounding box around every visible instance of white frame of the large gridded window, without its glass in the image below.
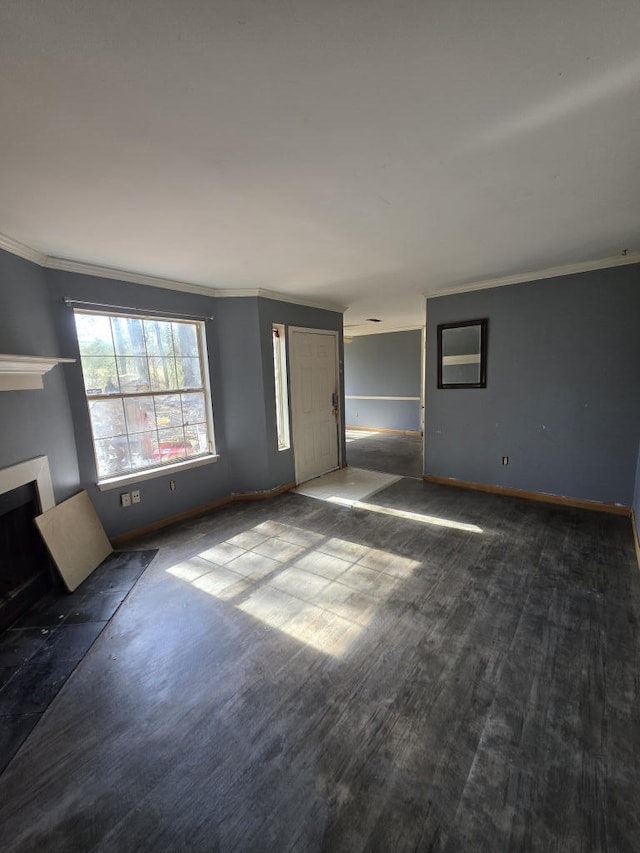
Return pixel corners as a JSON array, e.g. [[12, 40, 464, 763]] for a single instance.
[[74, 308, 220, 491]]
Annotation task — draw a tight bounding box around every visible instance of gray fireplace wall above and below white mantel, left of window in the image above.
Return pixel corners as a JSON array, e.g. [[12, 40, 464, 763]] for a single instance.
[[0, 250, 80, 501]]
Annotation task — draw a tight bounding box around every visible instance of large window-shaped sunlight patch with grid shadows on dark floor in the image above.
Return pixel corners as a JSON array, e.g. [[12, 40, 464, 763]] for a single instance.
[[167, 521, 420, 657]]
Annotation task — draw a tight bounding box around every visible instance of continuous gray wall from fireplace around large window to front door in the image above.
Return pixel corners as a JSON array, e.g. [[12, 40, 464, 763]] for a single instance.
[[0, 251, 342, 536]]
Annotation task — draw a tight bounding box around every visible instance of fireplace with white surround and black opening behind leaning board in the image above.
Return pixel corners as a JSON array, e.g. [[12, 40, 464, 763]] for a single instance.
[[0, 456, 55, 631]]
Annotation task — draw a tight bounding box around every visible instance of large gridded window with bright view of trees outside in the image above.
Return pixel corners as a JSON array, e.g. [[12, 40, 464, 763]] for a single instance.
[[75, 310, 215, 481]]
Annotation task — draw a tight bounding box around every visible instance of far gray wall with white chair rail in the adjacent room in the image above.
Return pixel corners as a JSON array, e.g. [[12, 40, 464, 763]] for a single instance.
[[344, 329, 422, 431]]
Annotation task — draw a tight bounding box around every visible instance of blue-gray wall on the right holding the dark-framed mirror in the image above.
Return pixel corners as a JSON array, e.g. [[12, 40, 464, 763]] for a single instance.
[[425, 265, 640, 506]]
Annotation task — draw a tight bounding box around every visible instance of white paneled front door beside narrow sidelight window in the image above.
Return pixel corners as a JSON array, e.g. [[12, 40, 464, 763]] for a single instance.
[[289, 327, 339, 483]]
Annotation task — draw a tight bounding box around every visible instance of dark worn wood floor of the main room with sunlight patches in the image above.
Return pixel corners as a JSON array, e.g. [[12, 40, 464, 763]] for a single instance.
[[0, 479, 640, 853]]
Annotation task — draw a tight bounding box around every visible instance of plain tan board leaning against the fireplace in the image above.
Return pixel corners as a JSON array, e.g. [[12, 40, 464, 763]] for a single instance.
[[35, 492, 113, 592]]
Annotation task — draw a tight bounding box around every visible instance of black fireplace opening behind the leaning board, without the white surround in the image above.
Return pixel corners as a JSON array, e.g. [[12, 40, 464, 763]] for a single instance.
[[0, 482, 54, 631]]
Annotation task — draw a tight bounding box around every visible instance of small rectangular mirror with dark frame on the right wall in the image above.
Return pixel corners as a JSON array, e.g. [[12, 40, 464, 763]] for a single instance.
[[438, 319, 488, 388]]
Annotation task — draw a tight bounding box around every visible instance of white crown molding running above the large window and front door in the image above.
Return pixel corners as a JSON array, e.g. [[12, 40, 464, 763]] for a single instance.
[[0, 234, 347, 314]]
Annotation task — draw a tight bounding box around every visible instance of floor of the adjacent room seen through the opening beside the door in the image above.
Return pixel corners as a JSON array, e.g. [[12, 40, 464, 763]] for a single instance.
[[346, 429, 422, 477]]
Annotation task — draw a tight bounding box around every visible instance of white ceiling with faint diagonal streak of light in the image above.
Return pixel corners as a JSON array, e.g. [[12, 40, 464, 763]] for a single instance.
[[0, 0, 640, 331]]
